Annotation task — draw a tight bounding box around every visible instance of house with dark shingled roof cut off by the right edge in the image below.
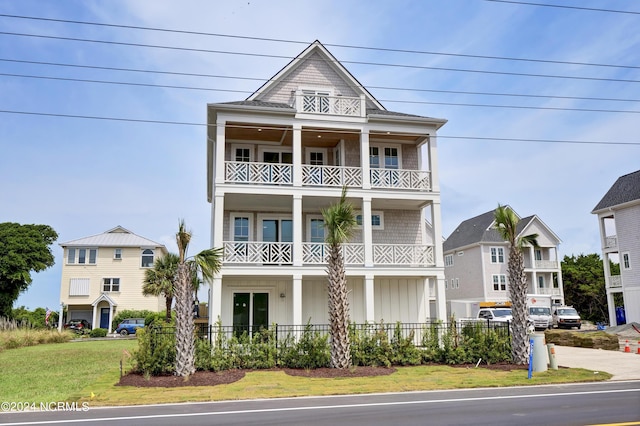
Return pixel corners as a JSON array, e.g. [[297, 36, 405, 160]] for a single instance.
[[591, 170, 640, 326]]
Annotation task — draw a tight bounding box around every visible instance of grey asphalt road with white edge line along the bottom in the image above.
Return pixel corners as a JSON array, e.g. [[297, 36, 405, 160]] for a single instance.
[[0, 381, 640, 426]]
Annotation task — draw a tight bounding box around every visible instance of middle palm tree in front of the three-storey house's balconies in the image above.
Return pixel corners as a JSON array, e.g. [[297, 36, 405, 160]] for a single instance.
[[322, 187, 356, 369]]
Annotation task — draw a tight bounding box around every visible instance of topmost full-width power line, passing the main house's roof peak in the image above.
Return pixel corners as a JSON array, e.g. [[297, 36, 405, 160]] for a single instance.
[[0, 14, 640, 69]]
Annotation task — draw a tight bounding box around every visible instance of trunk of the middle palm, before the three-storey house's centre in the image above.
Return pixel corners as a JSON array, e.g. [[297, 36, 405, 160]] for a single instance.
[[328, 245, 351, 369]]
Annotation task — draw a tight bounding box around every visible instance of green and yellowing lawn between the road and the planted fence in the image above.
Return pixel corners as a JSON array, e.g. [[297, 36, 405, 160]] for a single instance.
[[0, 339, 611, 406]]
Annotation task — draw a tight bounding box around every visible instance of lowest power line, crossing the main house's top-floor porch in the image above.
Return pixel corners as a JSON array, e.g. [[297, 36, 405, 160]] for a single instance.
[[0, 110, 640, 146]]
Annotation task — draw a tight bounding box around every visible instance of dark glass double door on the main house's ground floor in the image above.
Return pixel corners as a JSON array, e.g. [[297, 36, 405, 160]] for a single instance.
[[233, 293, 269, 336]]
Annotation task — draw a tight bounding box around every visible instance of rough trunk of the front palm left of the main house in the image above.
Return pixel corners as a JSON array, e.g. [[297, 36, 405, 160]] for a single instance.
[[175, 262, 196, 377]]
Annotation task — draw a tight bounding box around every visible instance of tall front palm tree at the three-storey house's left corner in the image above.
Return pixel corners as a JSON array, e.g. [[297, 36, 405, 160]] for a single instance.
[[175, 220, 222, 377]]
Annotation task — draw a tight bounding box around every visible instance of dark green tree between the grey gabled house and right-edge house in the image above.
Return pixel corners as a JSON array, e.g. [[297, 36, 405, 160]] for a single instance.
[[561, 253, 618, 322]]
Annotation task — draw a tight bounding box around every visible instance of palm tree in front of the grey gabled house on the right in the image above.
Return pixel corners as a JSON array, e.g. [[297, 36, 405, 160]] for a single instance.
[[494, 204, 538, 364]]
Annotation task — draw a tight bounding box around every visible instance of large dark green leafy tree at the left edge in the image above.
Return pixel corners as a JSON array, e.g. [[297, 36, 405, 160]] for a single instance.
[[0, 222, 58, 317]]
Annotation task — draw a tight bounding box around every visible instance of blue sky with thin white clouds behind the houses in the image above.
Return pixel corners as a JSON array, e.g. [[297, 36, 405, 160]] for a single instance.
[[0, 0, 640, 309]]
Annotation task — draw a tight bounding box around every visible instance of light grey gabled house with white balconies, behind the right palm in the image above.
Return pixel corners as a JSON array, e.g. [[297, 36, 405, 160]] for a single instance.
[[444, 210, 564, 312]]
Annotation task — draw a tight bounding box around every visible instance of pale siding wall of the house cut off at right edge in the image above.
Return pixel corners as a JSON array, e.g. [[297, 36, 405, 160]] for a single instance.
[[615, 205, 640, 288]]
